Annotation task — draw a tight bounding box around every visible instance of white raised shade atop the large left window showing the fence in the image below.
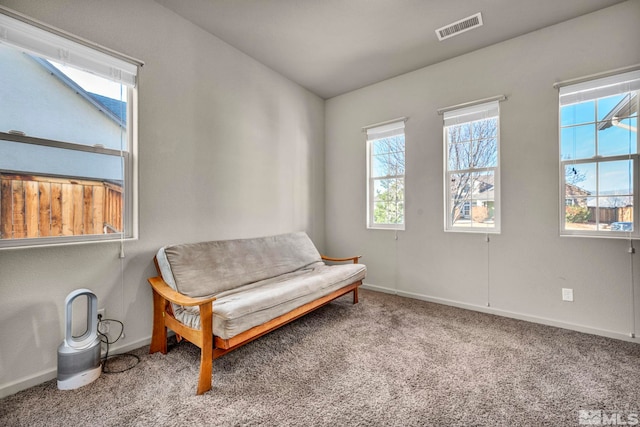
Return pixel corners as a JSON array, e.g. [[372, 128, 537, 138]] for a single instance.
[[0, 13, 138, 87]]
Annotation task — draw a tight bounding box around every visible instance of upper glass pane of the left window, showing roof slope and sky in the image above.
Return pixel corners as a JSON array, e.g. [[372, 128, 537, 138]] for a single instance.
[[0, 44, 127, 150]]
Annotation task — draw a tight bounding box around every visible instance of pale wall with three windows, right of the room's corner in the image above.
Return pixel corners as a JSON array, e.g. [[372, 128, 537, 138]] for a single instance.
[[325, 0, 640, 342]]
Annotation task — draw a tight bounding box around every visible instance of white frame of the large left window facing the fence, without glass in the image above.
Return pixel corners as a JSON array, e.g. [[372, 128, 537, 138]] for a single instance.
[[0, 8, 143, 250]]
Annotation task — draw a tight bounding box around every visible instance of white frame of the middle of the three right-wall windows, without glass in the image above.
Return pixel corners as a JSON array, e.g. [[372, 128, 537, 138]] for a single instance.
[[439, 100, 506, 234]]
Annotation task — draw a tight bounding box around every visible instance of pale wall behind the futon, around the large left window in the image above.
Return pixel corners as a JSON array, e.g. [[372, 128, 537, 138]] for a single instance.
[[0, 0, 324, 397]]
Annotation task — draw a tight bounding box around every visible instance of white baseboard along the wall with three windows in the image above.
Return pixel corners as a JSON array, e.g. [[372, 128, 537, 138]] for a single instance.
[[361, 284, 640, 343]]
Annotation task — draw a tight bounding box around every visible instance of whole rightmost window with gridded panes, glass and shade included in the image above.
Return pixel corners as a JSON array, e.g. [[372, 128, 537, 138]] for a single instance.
[[559, 71, 640, 238]]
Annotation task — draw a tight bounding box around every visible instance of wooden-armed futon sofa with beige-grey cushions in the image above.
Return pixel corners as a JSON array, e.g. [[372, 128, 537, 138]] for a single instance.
[[149, 232, 366, 394]]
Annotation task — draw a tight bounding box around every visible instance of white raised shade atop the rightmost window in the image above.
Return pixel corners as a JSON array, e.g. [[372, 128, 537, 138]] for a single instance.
[[560, 70, 640, 105]]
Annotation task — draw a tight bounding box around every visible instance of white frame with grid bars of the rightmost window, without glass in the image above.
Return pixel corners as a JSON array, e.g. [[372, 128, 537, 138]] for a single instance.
[[556, 71, 640, 239]]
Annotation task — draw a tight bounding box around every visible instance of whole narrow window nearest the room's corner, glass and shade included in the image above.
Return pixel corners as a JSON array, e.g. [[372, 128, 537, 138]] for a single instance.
[[366, 119, 405, 230]]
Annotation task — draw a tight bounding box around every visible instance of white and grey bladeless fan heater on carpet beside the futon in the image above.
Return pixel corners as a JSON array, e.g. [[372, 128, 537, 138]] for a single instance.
[[58, 289, 101, 390]]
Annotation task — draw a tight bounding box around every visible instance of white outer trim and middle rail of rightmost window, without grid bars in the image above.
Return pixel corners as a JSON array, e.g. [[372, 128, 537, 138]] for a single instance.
[[554, 70, 640, 239]]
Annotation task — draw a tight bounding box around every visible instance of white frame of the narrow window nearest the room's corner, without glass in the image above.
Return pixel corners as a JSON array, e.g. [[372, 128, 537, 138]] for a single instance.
[[363, 118, 407, 231]]
